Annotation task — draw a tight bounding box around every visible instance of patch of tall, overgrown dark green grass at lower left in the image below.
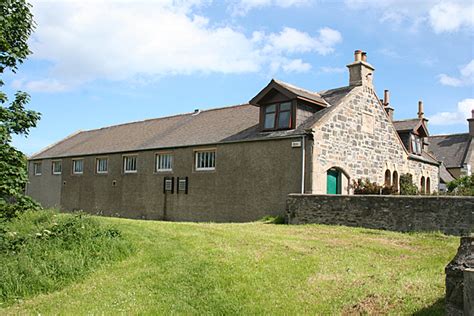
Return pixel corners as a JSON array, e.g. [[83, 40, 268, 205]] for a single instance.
[[0, 211, 131, 304]]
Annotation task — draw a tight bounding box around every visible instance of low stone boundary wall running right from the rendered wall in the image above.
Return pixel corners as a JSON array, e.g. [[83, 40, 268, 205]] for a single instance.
[[286, 194, 474, 235]]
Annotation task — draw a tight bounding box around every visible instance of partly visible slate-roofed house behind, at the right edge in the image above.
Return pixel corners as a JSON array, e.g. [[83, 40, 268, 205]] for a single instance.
[[428, 109, 474, 179]]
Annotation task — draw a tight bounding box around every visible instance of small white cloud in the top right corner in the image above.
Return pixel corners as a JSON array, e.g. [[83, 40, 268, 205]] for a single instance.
[[430, 1, 474, 33]]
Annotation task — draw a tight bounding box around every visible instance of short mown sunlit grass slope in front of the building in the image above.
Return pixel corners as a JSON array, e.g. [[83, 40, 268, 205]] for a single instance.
[[0, 218, 458, 315]]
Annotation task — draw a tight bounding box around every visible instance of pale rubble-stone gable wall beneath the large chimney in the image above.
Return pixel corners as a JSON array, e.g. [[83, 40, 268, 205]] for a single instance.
[[312, 86, 438, 194]]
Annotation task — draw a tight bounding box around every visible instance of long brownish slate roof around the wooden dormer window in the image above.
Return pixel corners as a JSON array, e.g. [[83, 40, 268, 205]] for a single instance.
[[30, 81, 353, 159]]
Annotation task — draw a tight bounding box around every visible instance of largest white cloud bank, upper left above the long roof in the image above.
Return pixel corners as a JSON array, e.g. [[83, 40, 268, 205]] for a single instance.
[[31, 0, 342, 89]]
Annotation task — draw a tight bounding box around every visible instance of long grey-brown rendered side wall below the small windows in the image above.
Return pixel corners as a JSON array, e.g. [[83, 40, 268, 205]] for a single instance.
[[30, 138, 311, 222]]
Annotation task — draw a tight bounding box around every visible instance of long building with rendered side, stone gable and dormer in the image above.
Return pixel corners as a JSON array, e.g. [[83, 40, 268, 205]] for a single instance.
[[27, 51, 439, 222]]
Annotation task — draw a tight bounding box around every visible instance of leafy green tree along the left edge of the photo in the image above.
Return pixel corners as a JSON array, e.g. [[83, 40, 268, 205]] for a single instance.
[[0, 0, 40, 217]]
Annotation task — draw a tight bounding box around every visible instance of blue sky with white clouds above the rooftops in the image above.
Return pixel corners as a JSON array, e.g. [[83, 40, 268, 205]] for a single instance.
[[4, 0, 474, 154]]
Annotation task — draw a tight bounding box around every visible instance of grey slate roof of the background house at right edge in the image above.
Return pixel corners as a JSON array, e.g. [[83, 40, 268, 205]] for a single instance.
[[428, 133, 471, 168]]
